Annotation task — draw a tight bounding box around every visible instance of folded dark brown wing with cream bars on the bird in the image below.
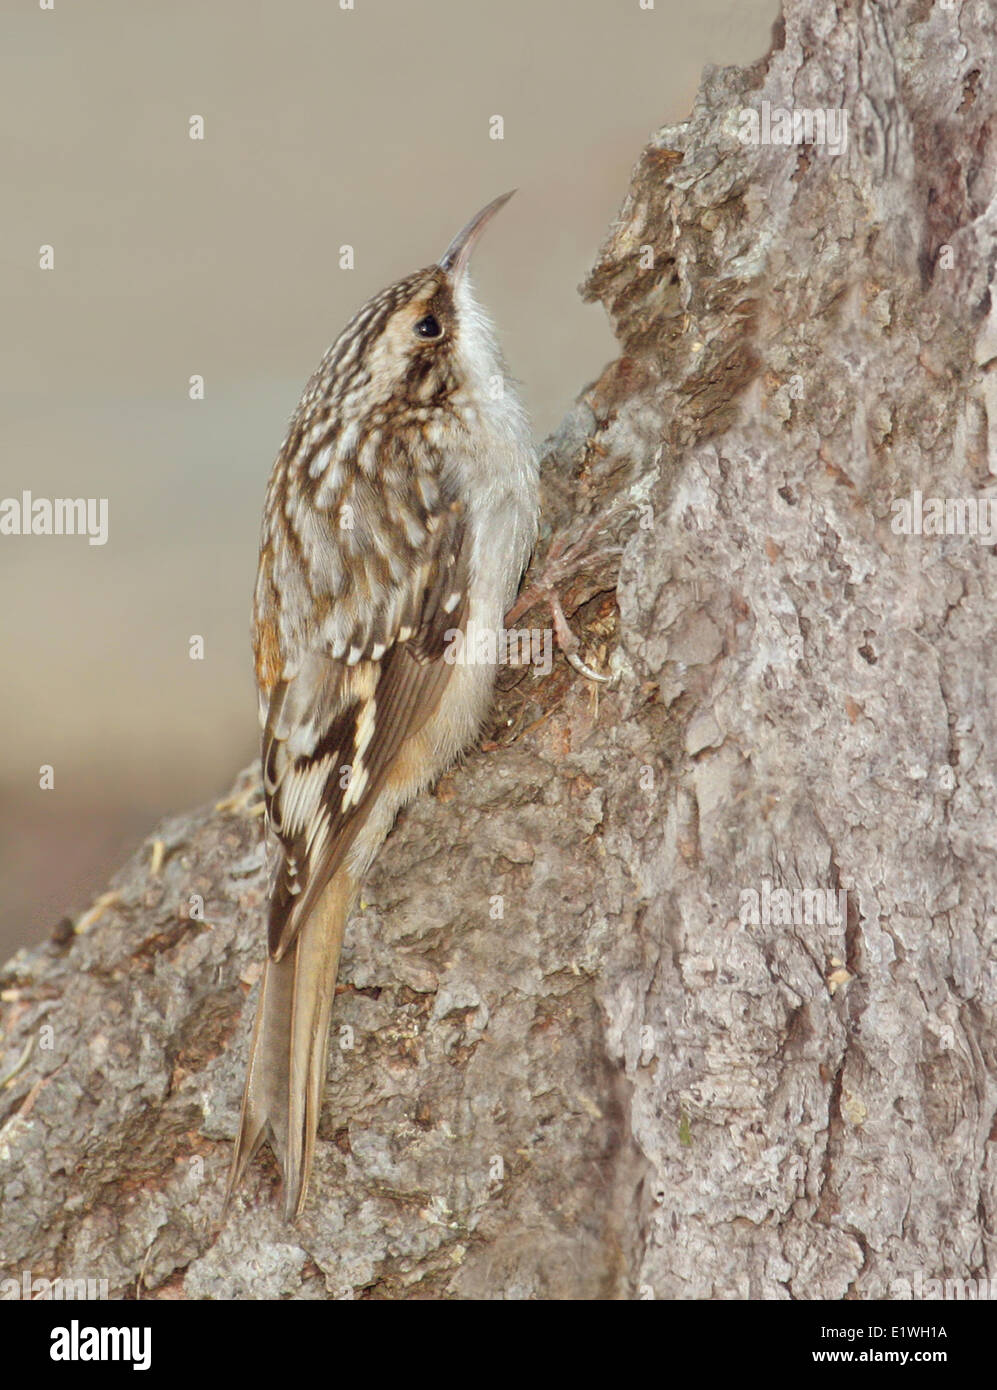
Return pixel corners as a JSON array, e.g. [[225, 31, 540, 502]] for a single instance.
[[263, 496, 469, 960]]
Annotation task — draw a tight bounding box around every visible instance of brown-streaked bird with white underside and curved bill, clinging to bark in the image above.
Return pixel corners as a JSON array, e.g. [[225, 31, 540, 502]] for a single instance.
[[228, 193, 538, 1219]]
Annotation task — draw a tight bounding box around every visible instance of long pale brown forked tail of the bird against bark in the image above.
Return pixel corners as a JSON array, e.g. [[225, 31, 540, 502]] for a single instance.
[[225, 869, 357, 1220]]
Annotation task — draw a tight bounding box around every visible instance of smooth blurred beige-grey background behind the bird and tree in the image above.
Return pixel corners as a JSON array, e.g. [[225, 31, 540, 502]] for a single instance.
[[0, 0, 779, 960]]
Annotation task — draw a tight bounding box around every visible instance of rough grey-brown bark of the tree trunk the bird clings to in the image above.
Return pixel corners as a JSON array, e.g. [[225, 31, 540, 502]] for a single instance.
[[0, 0, 997, 1298]]
